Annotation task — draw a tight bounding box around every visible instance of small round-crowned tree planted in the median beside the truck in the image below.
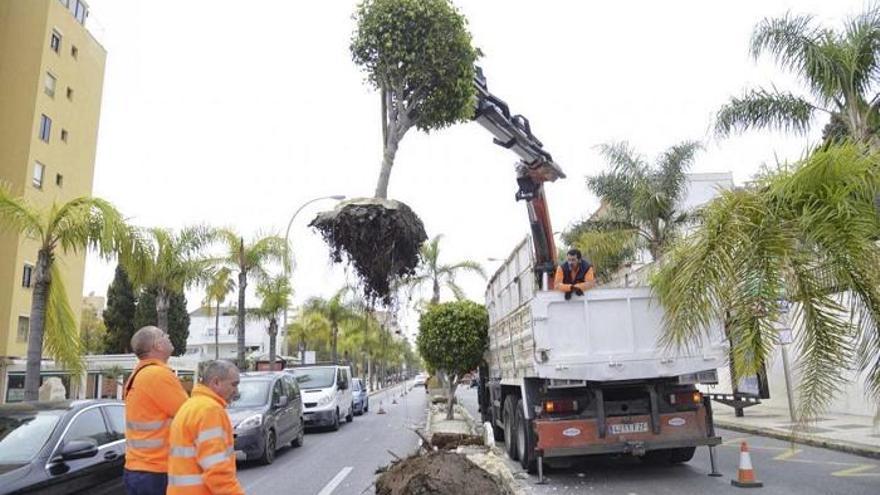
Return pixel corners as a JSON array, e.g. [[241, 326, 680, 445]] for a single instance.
[[416, 301, 489, 419]]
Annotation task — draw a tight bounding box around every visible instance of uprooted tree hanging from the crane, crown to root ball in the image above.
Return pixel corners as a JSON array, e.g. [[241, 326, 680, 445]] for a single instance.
[[311, 0, 479, 303]]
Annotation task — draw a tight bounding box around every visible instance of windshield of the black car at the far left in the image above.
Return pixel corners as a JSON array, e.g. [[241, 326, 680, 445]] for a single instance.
[[0, 411, 64, 464]]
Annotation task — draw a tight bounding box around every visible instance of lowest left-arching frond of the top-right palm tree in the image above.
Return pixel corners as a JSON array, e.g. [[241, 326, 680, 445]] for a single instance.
[[715, 89, 816, 136]]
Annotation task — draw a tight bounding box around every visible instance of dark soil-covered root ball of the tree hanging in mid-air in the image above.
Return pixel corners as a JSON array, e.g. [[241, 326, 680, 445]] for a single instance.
[[309, 198, 428, 304]]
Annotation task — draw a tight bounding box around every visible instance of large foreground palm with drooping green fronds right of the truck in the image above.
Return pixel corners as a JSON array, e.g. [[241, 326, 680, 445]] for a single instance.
[[653, 144, 880, 419]]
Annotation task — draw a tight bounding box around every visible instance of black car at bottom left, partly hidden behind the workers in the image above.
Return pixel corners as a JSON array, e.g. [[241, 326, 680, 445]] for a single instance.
[[0, 400, 125, 495]]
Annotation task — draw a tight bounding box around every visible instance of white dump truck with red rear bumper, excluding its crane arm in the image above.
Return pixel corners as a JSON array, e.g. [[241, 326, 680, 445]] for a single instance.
[[479, 237, 728, 472]]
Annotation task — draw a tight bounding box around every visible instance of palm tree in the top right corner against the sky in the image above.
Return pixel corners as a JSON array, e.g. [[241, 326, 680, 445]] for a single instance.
[[715, 6, 880, 149]]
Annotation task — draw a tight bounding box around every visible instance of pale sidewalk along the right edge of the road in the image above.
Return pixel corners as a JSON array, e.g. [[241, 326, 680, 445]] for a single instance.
[[712, 402, 880, 459]]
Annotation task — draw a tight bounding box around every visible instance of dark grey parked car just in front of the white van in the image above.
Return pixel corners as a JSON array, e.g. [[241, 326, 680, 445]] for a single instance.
[[228, 371, 305, 464]]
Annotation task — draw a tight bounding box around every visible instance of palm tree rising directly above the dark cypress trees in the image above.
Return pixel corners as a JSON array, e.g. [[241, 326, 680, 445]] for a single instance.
[[126, 225, 217, 332]]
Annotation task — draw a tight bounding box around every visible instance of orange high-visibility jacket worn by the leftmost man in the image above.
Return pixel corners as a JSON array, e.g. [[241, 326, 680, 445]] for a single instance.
[[125, 359, 187, 473]]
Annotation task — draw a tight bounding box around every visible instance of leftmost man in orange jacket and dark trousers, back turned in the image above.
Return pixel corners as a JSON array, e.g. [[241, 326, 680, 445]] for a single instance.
[[123, 326, 187, 495]]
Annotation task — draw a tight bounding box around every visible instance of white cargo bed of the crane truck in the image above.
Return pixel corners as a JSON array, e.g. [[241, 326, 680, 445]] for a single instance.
[[487, 287, 728, 382]]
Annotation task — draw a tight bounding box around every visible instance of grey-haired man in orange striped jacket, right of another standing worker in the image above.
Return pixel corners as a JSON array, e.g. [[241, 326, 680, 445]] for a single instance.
[[168, 361, 244, 495]]
